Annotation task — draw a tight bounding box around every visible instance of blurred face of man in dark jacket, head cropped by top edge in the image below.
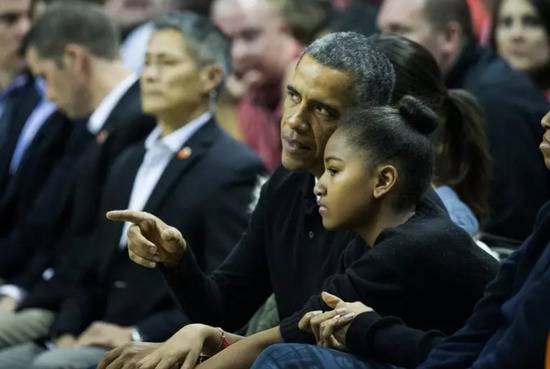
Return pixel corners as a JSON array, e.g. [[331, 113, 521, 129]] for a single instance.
[[377, 0, 452, 69]]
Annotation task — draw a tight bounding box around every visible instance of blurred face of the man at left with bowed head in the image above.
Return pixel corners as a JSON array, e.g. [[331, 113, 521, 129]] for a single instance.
[[26, 47, 90, 118]]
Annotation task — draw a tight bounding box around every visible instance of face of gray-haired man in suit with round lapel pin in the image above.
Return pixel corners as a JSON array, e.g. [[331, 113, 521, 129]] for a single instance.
[[141, 29, 208, 115]]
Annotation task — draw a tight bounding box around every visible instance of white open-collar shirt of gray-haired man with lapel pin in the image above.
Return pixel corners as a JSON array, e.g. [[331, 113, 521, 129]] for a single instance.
[[119, 112, 212, 248]]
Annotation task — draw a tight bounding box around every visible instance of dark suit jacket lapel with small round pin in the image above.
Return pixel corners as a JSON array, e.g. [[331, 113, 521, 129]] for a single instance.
[[144, 119, 220, 213]]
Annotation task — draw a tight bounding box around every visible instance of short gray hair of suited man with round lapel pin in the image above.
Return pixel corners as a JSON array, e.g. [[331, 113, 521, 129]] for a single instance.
[[153, 11, 231, 76]]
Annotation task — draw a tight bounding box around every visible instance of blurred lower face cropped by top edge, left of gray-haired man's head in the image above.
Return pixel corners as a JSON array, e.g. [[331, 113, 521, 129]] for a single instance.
[[104, 0, 170, 31]]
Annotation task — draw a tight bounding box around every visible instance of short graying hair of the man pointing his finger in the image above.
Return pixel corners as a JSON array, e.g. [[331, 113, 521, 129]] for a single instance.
[[304, 32, 395, 108]]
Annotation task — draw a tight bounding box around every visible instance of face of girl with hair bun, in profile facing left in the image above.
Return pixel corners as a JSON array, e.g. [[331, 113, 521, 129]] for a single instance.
[[314, 130, 377, 230]]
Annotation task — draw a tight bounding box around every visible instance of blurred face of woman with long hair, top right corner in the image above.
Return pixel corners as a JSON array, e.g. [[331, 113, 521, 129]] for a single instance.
[[495, 0, 550, 72]]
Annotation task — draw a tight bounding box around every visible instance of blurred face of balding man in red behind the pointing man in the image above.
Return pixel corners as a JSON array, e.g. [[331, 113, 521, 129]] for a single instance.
[[212, 0, 288, 87]]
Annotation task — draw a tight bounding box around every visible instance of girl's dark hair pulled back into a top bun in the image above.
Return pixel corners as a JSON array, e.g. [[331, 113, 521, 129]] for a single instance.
[[338, 96, 437, 210]]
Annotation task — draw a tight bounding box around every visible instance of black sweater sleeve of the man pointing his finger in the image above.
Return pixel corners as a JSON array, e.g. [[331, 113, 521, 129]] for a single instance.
[[161, 177, 272, 330]]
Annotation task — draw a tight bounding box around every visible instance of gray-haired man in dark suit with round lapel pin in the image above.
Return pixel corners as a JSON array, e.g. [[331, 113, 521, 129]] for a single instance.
[[0, 13, 264, 368]]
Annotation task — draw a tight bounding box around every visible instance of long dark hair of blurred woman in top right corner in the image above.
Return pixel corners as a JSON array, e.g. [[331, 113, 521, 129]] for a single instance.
[[490, 0, 550, 89]]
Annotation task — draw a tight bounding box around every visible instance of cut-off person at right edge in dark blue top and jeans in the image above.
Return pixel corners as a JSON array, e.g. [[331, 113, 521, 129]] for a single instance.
[[253, 108, 550, 369]]
